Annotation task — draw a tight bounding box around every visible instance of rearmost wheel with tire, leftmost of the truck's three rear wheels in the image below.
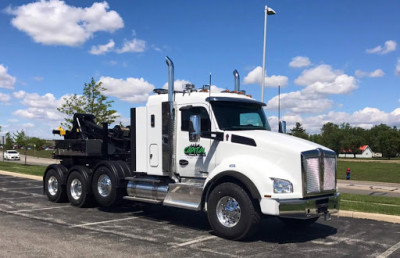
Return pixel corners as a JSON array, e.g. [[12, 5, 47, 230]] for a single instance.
[[44, 168, 67, 202]]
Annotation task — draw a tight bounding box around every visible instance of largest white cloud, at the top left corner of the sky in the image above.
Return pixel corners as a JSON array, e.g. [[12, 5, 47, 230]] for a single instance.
[[6, 0, 124, 46]]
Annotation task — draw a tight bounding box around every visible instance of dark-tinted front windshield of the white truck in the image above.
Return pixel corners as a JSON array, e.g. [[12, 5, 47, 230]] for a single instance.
[[211, 101, 271, 131]]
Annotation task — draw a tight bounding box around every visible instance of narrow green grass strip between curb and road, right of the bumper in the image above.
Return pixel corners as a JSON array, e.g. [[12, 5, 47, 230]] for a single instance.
[[340, 193, 400, 216]]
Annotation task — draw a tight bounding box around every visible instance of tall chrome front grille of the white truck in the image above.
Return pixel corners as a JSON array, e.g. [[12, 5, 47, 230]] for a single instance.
[[301, 149, 336, 196]]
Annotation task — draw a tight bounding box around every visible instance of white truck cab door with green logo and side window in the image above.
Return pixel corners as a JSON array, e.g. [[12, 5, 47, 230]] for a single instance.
[[176, 105, 216, 177]]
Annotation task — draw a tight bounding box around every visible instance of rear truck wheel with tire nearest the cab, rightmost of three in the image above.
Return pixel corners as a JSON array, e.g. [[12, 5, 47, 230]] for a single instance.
[[92, 166, 122, 207]]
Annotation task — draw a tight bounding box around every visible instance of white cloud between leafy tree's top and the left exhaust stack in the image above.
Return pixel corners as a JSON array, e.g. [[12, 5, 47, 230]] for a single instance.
[[99, 76, 154, 103]]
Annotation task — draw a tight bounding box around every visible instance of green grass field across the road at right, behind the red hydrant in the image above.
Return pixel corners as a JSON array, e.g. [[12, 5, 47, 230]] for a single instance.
[[337, 160, 400, 183]]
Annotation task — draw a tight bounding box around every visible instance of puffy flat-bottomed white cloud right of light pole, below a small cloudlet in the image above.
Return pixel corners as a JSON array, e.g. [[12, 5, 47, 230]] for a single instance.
[[295, 64, 358, 94]]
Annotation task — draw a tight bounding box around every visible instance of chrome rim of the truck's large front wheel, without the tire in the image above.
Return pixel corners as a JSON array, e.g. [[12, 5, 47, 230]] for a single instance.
[[217, 196, 242, 228]]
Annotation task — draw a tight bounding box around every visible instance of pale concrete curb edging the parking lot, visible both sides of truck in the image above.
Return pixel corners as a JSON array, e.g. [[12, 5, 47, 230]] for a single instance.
[[0, 170, 400, 224]]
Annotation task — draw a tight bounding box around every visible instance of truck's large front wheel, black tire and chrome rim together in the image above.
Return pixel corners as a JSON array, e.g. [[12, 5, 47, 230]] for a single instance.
[[207, 182, 260, 240]]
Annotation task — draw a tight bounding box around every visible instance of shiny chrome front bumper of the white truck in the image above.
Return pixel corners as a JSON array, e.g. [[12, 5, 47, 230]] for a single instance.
[[277, 193, 340, 219]]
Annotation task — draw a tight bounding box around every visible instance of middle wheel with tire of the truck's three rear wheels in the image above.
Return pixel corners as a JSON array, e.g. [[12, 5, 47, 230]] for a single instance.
[[67, 171, 92, 207]]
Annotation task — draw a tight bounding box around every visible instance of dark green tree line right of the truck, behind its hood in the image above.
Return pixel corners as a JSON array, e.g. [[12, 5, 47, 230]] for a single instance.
[[289, 122, 400, 159]]
